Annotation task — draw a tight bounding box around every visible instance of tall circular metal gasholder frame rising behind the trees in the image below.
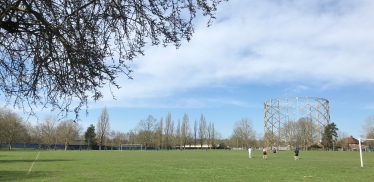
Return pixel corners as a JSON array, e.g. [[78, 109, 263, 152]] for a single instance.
[[264, 97, 330, 146]]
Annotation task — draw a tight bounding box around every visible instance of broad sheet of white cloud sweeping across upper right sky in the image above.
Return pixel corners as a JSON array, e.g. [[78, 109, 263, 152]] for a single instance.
[[65, 0, 374, 107]]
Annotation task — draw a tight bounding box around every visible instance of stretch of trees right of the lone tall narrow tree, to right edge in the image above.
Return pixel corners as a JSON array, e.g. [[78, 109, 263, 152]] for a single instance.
[[79, 113, 374, 150]]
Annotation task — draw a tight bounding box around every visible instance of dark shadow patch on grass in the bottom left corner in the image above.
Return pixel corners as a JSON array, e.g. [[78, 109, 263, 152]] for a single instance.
[[0, 171, 54, 181]]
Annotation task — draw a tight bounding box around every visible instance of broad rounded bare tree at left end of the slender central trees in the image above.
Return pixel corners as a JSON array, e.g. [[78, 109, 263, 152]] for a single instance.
[[136, 115, 157, 150]]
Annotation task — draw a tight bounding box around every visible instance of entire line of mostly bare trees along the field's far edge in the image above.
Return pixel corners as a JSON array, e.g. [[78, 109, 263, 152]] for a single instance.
[[0, 107, 374, 150]]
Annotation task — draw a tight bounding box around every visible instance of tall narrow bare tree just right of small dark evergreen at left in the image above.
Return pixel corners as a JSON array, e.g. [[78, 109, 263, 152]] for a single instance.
[[96, 107, 110, 150]]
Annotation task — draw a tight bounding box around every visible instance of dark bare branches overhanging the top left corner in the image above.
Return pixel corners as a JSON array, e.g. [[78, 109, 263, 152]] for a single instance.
[[0, 0, 227, 117]]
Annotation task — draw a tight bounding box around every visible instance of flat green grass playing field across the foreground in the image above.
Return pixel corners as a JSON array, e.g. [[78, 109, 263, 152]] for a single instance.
[[0, 150, 374, 182]]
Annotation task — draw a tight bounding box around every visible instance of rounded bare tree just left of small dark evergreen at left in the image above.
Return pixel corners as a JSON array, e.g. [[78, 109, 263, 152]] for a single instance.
[[57, 120, 83, 150]]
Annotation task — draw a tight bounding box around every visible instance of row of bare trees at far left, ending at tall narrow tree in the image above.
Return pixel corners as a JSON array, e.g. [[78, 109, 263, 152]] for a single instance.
[[0, 107, 112, 150]]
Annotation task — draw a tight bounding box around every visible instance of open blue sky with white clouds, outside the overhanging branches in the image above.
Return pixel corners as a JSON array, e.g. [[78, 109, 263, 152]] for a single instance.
[[2, 0, 374, 138]]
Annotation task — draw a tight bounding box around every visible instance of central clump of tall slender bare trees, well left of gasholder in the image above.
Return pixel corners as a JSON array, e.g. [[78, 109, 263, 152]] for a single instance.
[[135, 113, 221, 148]]
